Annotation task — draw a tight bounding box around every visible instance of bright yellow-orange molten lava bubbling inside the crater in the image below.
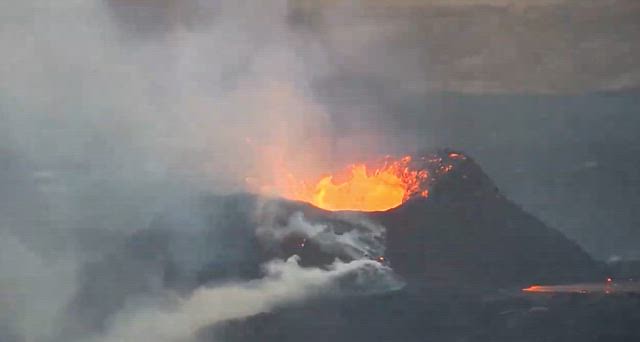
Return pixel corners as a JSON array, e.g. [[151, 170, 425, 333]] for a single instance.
[[282, 156, 429, 211]]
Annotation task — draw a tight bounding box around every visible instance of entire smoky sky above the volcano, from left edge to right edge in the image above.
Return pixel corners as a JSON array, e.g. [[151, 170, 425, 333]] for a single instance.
[[0, 0, 640, 341]]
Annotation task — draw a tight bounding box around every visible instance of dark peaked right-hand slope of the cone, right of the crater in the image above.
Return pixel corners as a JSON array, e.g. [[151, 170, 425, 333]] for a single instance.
[[373, 152, 599, 287]]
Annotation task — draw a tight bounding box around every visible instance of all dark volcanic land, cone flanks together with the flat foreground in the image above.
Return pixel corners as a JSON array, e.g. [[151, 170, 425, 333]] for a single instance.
[[62, 151, 640, 341]]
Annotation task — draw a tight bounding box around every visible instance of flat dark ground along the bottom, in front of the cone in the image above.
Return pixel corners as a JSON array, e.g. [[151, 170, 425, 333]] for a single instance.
[[209, 291, 640, 342]]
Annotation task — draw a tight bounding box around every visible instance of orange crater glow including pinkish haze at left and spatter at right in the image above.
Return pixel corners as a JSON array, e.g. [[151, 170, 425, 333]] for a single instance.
[[245, 152, 466, 211]]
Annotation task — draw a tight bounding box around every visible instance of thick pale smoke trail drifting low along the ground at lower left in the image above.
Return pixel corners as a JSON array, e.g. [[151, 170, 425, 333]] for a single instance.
[[96, 256, 399, 342]]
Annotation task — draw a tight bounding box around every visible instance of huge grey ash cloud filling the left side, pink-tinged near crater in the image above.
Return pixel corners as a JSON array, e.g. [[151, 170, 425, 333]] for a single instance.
[[0, 0, 338, 341]]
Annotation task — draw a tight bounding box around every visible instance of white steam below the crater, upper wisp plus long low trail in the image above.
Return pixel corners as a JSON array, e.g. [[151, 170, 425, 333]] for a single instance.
[[95, 213, 403, 342]]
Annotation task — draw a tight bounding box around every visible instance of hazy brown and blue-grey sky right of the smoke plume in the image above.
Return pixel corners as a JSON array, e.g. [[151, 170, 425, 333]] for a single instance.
[[294, 0, 640, 259]]
